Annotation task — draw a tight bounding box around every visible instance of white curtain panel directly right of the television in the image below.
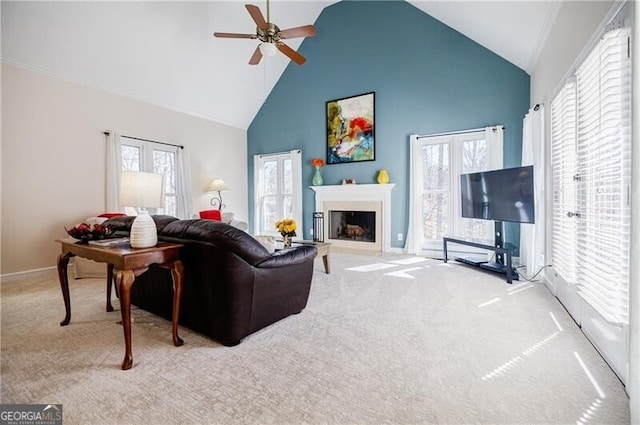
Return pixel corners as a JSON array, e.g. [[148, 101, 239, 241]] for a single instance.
[[520, 105, 546, 275]]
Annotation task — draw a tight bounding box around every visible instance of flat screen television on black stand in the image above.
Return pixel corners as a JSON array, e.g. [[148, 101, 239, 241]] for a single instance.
[[460, 165, 535, 223]]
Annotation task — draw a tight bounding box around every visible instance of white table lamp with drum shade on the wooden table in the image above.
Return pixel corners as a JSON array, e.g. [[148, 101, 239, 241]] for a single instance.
[[120, 171, 165, 248]]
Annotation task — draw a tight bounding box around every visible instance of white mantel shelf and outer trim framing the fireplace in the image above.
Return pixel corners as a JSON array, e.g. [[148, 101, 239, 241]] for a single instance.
[[310, 183, 395, 252]]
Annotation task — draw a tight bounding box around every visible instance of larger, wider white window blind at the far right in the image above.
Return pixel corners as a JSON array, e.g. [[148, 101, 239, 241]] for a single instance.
[[576, 28, 631, 323]]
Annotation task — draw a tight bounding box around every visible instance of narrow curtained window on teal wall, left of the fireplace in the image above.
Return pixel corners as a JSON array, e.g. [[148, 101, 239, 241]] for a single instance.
[[254, 151, 303, 237]]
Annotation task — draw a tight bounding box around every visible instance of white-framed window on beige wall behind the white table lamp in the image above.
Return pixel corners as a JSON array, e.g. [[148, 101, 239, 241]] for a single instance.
[[120, 136, 179, 217]]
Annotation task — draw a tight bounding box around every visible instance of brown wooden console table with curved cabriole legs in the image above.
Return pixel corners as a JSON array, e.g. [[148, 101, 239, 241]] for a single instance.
[[56, 238, 183, 370]]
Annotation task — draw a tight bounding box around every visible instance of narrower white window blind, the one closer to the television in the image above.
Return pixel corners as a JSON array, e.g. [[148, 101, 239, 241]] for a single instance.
[[551, 82, 577, 283]]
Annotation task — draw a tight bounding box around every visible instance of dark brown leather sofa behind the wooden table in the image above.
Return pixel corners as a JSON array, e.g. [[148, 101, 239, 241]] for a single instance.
[[105, 216, 317, 346]]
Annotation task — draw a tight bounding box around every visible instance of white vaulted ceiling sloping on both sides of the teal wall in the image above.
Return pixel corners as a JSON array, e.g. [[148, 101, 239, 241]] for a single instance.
[[1, 0, 560, 128]]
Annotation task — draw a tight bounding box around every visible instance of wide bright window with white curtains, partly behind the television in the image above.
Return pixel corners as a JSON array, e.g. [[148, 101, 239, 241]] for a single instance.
[[408, 128, 502, 252]]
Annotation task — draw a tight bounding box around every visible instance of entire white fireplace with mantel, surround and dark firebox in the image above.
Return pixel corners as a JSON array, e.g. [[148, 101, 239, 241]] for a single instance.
[[311, 184, 394, 252]]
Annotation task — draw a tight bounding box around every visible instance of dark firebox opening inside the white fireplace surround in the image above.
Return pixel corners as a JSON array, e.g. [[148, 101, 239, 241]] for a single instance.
[[329, 210, 376, 242]]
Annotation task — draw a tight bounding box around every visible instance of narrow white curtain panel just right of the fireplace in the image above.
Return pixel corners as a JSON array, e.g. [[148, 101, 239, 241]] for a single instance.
[[404, 134, 422, 254]]
